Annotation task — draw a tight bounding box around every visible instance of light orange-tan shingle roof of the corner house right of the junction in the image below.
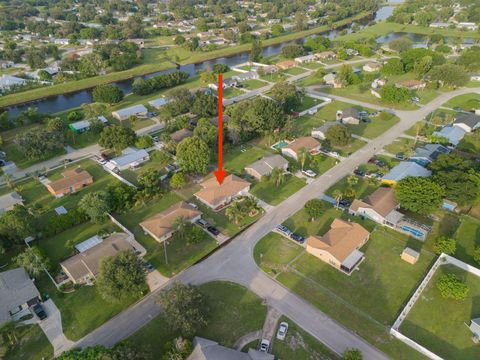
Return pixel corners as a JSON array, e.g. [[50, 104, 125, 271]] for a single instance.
[[307, 219, 370, 262]]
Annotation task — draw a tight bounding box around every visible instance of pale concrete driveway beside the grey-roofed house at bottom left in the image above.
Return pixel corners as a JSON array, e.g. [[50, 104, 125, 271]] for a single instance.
[[38, 299, 75, 356]]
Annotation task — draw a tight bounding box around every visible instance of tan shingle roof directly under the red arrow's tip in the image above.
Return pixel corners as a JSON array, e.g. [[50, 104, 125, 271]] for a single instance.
[[195, 174, 250, 205]]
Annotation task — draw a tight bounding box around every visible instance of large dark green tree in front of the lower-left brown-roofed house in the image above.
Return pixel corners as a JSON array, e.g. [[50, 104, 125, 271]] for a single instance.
[[97, 250, 147, 302]]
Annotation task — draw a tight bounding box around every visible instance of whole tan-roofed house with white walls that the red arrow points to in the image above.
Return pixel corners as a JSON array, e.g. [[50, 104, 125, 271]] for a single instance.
[[194, 174, 250, 210]]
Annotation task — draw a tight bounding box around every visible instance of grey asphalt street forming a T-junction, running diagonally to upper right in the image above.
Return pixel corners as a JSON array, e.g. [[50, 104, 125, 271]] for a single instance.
[[76, 88, 480, 359]]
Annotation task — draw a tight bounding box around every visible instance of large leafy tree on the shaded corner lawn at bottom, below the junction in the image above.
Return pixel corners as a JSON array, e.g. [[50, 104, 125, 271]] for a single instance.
[[157, 282, 208, 337]]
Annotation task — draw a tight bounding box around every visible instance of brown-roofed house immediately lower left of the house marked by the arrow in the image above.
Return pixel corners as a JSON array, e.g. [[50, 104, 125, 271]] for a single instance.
[[140, 201, 202, 242]]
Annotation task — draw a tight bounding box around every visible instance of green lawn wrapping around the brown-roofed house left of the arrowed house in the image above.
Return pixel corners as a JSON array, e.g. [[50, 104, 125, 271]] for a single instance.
[[116, 192, 216, 277]]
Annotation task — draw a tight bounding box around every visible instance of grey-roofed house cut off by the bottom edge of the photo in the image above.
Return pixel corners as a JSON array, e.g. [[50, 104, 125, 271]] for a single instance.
[[187, 336, 275, 360]]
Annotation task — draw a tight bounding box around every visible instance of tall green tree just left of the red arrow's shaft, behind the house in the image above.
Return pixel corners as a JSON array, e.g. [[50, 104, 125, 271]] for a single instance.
[[177, 136, 210, 174]]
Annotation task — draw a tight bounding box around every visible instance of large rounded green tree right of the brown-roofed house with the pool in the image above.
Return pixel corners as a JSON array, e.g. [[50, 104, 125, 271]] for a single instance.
[[395, 176, 445, 214]]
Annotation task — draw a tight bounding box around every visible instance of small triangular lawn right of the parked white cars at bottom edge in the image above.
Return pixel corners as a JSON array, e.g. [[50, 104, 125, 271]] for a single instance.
[[272, 316, 340, 360]]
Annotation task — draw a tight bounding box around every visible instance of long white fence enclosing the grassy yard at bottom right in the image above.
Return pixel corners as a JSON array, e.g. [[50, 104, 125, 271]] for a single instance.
[[390, 253, 480, 360]]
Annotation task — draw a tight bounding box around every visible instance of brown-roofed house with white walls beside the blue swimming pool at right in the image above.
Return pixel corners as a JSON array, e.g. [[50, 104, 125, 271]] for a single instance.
[[348, 187, 403, 227]]
